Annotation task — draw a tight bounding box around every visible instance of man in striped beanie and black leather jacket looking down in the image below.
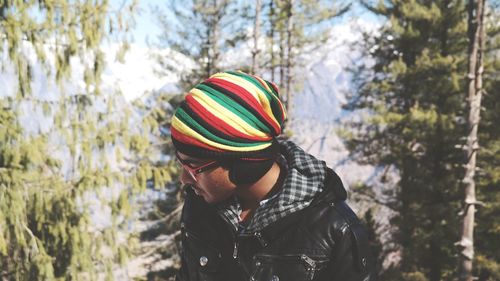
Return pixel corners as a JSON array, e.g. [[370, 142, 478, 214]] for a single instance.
[[171, 71, 371, 281]]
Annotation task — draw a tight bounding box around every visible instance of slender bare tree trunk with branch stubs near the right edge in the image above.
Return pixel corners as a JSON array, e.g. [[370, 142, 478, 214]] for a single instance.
[[458, 0, 486, 281]]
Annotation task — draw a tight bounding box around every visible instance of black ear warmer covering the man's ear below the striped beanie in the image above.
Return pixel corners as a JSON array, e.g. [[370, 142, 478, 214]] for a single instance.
[[228, 159, 274, 185]]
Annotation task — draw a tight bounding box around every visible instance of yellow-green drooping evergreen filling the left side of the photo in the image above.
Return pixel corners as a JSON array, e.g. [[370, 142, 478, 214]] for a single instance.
[[0, 0, 169, 280]]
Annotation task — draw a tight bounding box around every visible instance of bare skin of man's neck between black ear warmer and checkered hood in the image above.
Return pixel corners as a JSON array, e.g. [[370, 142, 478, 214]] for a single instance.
[[236, 160, 281, 212]]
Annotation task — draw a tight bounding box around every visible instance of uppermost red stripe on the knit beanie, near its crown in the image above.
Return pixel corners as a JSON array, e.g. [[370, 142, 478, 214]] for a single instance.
[[203, 78, 281, 134]]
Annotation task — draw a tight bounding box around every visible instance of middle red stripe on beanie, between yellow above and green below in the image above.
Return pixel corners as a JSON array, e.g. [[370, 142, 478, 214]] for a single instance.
[[186, 95, 272, 141]]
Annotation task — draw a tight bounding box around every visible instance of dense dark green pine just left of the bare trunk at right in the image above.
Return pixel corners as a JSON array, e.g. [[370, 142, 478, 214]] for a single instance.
[[346, 0, 498, 280]]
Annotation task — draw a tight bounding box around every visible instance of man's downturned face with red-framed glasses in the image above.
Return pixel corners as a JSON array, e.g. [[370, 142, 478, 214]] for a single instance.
[[177, 152, 236, 204]]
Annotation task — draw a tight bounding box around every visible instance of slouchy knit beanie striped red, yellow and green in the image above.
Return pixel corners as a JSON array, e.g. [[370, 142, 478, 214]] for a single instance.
[[171, 71, 286, 160]]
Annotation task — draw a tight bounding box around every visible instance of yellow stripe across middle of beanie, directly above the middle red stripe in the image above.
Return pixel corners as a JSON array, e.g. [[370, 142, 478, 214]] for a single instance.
[[189, 88, 269, 138]]
